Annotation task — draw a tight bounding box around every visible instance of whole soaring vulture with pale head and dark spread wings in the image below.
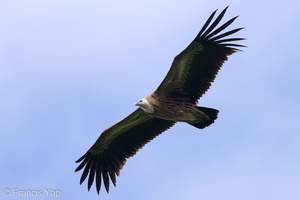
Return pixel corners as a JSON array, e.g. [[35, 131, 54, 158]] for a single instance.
[[75, 6, 245, 194]]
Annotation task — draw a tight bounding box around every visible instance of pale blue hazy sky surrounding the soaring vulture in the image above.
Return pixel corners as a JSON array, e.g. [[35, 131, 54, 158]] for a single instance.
[[0, 0, 300, 200]]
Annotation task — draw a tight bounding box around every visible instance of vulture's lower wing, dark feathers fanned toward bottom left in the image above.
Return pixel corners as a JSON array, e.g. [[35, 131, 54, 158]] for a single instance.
[[75, 108, 175, 194]]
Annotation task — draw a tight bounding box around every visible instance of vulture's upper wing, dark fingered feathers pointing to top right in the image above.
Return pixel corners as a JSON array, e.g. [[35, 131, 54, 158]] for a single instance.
[[156, 7, 244, 104]]
